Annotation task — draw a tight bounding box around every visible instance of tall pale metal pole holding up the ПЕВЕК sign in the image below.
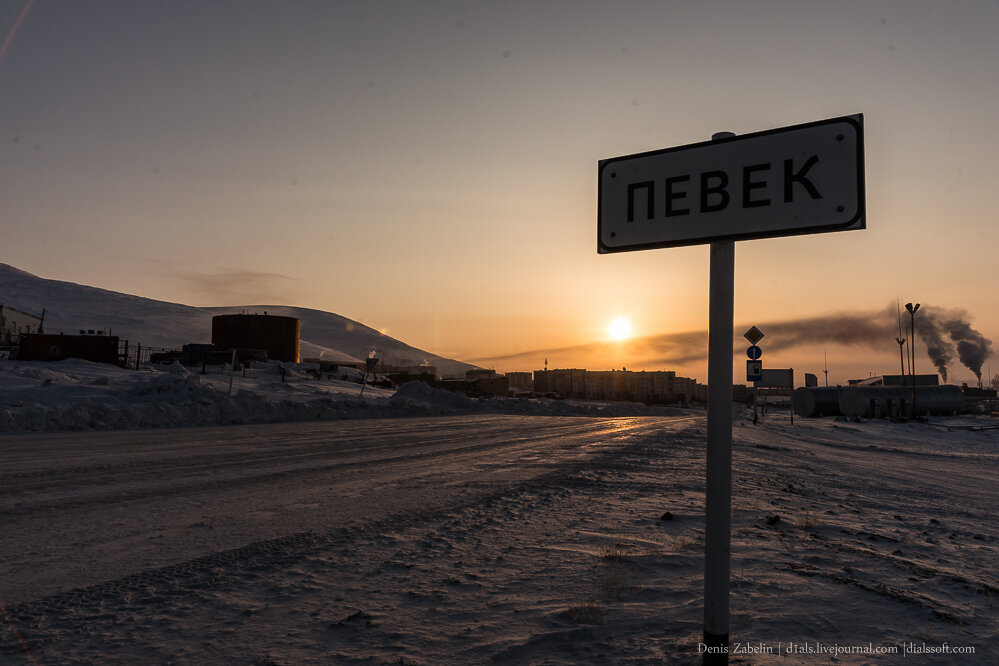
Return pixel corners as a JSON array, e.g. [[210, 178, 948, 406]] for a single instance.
[[704, 132, 735, 664]]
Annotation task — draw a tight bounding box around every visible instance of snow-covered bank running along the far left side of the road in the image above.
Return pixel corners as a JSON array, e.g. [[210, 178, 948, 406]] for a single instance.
[[0, 359, 678, 432]]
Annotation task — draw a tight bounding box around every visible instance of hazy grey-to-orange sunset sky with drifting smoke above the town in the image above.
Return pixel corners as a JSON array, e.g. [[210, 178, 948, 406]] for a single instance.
[[0, 0, 999, 382]]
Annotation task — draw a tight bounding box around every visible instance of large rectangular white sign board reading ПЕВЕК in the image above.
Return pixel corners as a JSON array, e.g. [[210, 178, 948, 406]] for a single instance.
[[597, 114, 866, 254]]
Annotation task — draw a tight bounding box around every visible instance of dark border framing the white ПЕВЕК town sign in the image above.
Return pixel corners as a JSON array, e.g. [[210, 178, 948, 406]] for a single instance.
[[597, 113, 867, 254]]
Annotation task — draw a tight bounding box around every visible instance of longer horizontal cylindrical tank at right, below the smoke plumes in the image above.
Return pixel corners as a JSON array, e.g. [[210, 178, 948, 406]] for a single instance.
[[839, 386, 964, 418]]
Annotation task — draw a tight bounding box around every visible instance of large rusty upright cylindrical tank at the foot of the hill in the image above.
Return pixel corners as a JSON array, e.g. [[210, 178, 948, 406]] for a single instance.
[[212, 314, 301, 363]]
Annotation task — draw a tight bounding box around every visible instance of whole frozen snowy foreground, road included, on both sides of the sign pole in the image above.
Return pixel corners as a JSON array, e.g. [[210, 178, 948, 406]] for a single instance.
[[0, 412, 999, 664]]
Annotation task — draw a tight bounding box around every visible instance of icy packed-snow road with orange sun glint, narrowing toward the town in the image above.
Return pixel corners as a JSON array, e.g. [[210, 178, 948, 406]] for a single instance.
[[0, 415, 684, 604]]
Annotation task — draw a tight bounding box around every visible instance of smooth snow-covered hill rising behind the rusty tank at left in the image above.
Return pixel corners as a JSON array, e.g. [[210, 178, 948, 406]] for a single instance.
[[0, 264, 475, 375]]
